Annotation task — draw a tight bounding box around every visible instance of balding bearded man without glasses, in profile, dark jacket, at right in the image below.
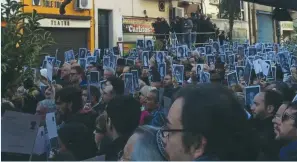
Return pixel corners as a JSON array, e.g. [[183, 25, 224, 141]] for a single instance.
[[251, 90, 283, 161]]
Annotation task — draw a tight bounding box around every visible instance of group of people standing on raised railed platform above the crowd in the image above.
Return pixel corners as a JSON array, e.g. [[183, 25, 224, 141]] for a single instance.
[[152, 13, 221, 46]]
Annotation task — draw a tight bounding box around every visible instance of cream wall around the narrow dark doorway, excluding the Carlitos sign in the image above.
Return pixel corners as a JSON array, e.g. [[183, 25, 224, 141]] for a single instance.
[[94, 0, 169, 48]]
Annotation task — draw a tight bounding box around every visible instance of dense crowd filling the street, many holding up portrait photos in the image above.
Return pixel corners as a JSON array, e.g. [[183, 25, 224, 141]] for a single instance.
[[1, 39, 297, 161]]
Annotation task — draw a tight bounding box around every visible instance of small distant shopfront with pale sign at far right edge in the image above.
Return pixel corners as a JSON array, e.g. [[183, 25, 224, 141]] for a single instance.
[[280, 21, 295, 41]]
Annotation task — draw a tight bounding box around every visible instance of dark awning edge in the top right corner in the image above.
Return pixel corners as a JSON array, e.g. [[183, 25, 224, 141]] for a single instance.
[[243, 0, 297, 11]]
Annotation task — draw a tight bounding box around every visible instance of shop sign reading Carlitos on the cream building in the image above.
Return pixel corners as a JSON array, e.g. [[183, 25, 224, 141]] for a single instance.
[[123, 17, 157, 33]]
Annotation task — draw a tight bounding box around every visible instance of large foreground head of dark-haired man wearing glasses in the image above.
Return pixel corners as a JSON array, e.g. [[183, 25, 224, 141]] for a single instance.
[[158, 84, 256, 161]]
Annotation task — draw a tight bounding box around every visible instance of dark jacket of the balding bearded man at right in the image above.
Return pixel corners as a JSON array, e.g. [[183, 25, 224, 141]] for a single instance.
[[252, 117, 282, 161]]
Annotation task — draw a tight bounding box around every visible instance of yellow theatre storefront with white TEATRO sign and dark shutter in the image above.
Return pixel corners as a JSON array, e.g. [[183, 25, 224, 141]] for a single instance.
[[23, 0, 95, 60]]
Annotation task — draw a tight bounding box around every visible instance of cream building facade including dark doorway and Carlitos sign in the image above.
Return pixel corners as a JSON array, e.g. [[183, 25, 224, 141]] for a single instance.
[[94, 0, 169, 49]]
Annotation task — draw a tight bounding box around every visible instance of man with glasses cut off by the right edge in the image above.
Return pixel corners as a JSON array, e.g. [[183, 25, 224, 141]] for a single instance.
[[274, 101, 297, 161]]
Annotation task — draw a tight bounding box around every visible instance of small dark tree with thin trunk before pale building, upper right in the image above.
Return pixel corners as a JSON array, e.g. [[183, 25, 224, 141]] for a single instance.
[[219, 0, 241, 41]]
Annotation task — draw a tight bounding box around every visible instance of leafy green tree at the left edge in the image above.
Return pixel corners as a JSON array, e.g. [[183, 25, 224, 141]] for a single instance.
[[1, 0, 55, 89]]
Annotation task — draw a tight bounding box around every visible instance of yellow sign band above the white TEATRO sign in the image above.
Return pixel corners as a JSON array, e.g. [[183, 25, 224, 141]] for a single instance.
[[22, 0, 92, 16]]
